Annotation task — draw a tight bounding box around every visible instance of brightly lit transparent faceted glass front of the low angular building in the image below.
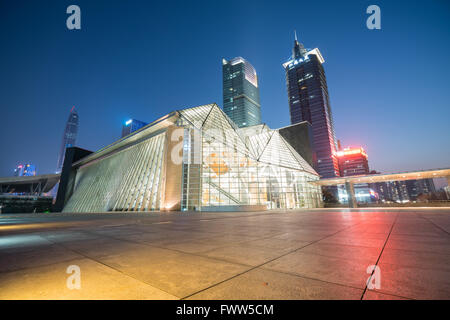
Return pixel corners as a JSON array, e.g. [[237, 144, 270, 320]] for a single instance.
[[178, 106, 321, 210]]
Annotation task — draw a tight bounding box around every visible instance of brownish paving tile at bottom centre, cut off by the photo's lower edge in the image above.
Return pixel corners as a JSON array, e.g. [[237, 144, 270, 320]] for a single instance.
[[188, 269, 363, 300]]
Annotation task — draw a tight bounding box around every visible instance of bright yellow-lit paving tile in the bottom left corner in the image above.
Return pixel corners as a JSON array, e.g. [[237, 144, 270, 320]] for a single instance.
[[0, 259, 178, 300]]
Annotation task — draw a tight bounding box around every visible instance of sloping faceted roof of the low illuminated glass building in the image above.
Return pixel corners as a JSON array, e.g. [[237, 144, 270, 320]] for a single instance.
[[74, 103, 317, 175]]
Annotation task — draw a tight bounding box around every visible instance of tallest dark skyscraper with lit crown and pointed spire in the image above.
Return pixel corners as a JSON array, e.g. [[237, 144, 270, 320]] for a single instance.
[[283, 35, 339, 178]]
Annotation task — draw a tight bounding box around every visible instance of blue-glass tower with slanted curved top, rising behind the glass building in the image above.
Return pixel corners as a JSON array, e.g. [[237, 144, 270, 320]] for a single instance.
[[222, 57, 261, 128]]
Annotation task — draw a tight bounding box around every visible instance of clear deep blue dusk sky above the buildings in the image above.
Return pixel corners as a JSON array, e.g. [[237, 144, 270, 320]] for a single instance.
[[0, 0, 450, 182]]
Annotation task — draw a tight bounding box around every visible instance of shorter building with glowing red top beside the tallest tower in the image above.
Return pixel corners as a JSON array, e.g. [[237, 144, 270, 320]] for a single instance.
[[336, 147, 369, 177]]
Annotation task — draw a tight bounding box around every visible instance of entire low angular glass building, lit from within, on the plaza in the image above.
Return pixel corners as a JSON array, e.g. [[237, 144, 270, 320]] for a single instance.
[[63, 104, 322, 212]]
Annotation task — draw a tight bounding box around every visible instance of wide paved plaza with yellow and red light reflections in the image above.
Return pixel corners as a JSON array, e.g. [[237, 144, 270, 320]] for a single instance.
[[0, 208, 450, 300]]
